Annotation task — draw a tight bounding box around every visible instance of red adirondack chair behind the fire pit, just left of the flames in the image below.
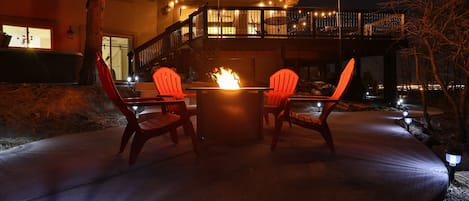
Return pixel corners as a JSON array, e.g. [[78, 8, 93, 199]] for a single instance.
[[152, 67, 197, 116]]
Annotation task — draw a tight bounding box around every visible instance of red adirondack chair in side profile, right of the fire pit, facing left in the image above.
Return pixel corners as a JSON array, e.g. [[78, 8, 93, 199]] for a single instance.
[[270, 58, 355, 153]]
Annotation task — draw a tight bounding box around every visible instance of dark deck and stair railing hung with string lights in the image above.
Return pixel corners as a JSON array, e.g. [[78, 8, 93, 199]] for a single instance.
[[135, 6, 404, 72]]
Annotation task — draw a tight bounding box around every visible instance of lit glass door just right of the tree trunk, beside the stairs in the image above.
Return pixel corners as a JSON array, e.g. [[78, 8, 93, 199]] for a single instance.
[[101, 36, 132, 80]]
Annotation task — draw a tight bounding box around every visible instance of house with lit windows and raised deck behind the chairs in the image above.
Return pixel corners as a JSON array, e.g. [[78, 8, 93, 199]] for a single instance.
[[0, 0, 403, 103]]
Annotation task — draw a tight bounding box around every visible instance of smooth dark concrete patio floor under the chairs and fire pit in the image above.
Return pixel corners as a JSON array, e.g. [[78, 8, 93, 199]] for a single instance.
[[0, 111, 448, 201]]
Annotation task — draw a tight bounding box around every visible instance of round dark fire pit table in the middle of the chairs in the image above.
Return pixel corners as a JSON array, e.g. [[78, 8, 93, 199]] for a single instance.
[[187, 87, 271, 144]]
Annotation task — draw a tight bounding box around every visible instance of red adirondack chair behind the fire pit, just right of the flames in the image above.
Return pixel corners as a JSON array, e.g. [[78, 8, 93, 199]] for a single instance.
[[264, 68, 298, 125]]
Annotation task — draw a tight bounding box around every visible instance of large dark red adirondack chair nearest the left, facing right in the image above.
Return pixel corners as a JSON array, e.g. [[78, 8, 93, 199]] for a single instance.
[[96, 53, 198, 165]]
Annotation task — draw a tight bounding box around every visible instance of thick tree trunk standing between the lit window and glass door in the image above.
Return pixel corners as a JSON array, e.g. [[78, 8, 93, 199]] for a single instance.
[[79, 0, 105, 85]]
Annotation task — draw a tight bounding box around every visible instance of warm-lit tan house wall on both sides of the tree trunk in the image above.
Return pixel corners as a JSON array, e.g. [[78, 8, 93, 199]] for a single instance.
[[0, 0, 157, 52]]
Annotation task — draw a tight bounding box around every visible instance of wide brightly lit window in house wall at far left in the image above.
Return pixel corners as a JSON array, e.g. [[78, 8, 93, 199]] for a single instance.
[[2, 25, 52, 49]]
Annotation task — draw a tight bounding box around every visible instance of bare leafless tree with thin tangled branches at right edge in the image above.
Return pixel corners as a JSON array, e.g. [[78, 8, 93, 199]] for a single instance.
[[386, 0, 469, 143]]
